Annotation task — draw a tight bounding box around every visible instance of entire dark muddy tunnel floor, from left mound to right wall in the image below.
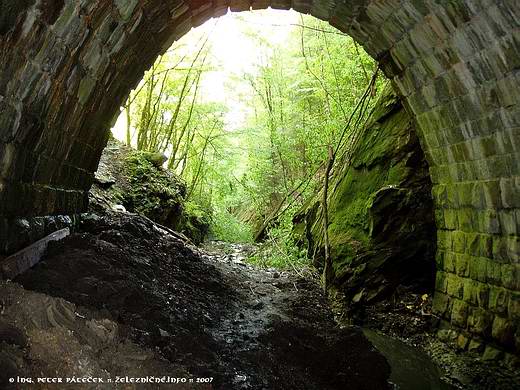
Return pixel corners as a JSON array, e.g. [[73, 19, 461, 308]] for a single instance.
[[0, 214, 520, 390]]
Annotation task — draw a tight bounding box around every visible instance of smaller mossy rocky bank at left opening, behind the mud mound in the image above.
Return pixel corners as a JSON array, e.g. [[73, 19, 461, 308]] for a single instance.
[[89, 139, 209, 243]]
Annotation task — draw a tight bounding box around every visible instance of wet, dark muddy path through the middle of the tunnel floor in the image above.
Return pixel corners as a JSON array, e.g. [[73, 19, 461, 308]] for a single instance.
[[199, 242, 389, 389]]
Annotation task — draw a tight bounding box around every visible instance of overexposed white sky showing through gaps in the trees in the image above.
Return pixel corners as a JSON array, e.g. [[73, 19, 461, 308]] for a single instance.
[[112, 9, 299, 140]]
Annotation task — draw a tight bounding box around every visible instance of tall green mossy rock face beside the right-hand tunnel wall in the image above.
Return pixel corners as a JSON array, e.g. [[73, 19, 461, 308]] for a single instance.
[[294, 90, 436, 306]]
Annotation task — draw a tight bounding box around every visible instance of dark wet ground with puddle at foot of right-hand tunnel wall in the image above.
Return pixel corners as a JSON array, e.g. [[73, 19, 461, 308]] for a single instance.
[[350, 286, 520, 390]]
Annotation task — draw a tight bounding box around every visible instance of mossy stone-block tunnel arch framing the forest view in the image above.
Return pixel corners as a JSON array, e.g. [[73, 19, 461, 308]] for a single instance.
[[0, 0, 520, 354]]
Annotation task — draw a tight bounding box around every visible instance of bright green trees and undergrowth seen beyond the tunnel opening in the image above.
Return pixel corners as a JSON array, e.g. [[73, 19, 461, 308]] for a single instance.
[[117, 15, 385, 272]]
